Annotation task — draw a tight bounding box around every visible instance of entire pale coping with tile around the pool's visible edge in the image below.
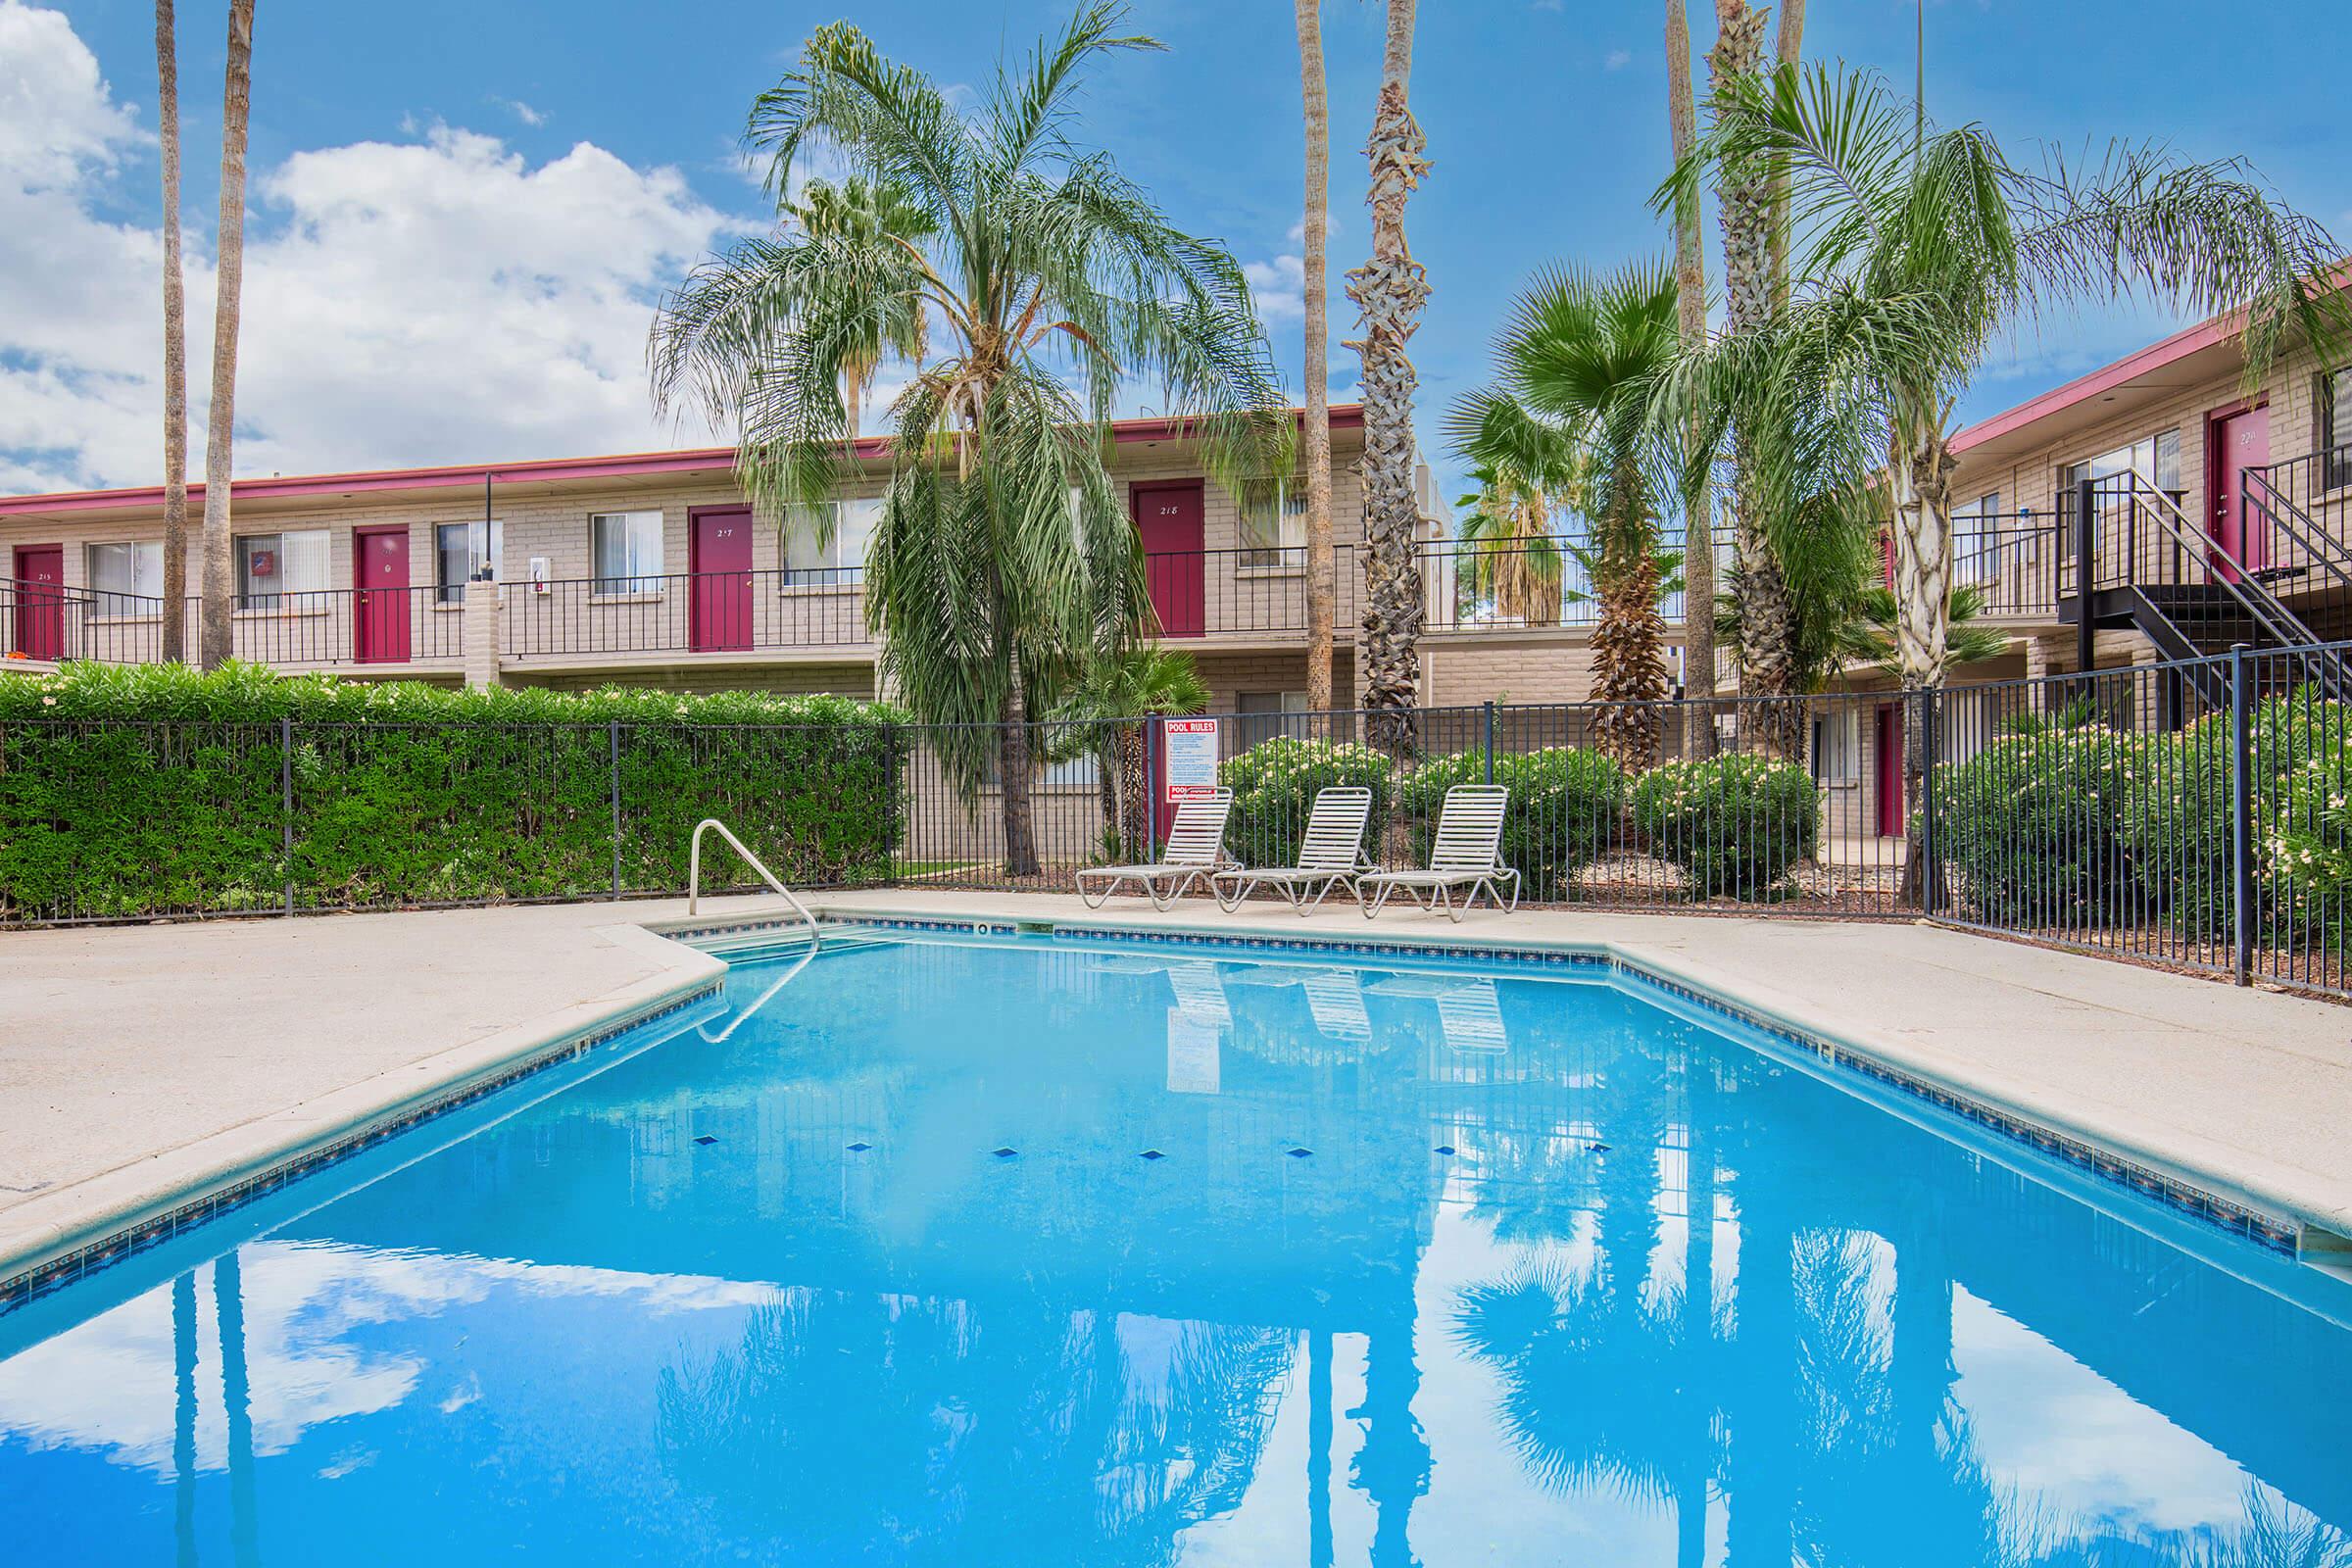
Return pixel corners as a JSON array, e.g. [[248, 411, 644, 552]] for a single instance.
[[0, 901, 2352, 1314]]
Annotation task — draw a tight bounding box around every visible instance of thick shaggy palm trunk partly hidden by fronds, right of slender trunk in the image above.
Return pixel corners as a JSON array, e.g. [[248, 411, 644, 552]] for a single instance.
[[1707, 0, 1804, 761]]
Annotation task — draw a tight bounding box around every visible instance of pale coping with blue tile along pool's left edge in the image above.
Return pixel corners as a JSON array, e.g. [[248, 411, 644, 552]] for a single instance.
[[0, 921, 727, 1314]]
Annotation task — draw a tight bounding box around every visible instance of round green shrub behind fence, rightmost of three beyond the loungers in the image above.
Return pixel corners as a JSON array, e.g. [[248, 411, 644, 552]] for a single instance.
[[1633, 755, 1821, 901]]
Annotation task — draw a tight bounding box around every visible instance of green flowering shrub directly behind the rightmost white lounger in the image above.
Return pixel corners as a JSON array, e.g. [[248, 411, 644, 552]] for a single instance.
[[1397, 745, 1625, 898]]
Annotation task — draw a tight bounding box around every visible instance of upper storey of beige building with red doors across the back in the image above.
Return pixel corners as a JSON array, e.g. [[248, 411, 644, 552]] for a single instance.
[[0, 407, 1693, 712]]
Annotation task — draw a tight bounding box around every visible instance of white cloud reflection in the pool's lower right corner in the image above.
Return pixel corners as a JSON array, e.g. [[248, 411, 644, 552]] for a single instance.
[[1952, 1286, 2246, 1531]]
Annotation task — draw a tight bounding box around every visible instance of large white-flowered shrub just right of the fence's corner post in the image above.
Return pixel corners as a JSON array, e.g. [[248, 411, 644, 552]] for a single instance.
[[1936, 724, 2133, 926]]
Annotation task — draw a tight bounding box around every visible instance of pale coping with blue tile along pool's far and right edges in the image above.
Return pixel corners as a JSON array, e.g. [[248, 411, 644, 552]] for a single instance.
[[761, 901, 2352, 1274]]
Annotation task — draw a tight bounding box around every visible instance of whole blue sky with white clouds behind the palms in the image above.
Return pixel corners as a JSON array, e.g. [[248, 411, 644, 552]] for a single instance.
[[18, 0, 2352, 505]]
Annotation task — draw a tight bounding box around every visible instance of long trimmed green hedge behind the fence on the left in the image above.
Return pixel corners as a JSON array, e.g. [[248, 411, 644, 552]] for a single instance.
[[0, 665, 907, 919]]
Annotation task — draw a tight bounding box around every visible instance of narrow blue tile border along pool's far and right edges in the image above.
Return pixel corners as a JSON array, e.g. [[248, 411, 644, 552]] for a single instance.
[[821, 914, 2303, 1257]]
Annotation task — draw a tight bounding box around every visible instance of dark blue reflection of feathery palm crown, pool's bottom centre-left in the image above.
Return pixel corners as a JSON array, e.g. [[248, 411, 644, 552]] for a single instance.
[[657, 1291, 1296, 1563]]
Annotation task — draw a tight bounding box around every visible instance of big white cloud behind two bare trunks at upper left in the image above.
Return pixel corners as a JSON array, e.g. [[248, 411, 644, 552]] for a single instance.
[[0, 0, 729, 491]]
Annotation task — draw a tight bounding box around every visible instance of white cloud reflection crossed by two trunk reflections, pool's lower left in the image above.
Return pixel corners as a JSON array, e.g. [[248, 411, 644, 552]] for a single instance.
[[0, 1242, 771, 1476]]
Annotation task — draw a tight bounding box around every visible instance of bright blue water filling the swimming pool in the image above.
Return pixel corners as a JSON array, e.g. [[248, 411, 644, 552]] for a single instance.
[[0, 938, 2352, 1568]]
